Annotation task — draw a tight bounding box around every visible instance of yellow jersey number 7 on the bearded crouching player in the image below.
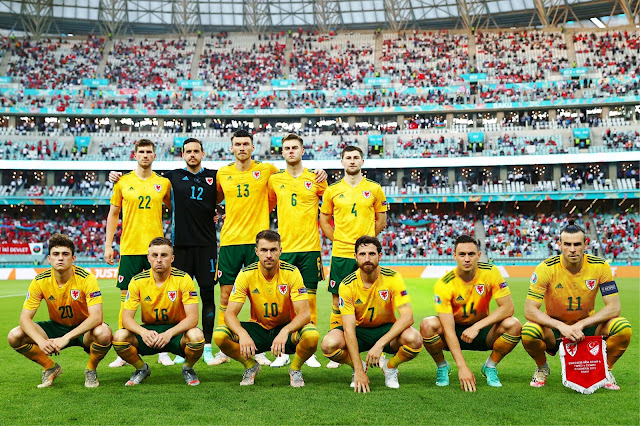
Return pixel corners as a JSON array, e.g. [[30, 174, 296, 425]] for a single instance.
[[338, 267, 411, 328]]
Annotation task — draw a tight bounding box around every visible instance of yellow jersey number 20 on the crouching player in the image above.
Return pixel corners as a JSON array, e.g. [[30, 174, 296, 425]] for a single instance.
[[22, 266, 102, 326]]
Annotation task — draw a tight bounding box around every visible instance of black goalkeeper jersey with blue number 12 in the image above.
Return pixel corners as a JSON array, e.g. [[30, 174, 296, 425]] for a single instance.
[[164, 167, 217, 247]]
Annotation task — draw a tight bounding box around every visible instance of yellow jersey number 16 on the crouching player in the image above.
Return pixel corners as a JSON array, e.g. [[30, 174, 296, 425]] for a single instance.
[[124, 268, 198, 324]]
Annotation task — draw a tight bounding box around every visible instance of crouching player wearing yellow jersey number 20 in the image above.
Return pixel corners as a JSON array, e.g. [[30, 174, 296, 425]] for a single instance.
[[8, 234, 111, 388]]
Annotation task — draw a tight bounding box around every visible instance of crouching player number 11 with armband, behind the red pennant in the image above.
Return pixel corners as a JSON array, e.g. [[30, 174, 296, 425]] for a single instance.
[[522, 223, 631, 390]]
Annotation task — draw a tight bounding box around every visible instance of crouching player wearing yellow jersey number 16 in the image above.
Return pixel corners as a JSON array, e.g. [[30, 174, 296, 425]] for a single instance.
[[113, 237, 204, 386]]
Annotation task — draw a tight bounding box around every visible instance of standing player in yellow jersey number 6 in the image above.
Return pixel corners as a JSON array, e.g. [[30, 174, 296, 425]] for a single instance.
[[269, 133, 327, 367]]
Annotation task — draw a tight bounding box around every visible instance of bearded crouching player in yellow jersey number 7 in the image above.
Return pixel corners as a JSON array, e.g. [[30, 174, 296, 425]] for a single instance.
[[322, 235, 422, 393]]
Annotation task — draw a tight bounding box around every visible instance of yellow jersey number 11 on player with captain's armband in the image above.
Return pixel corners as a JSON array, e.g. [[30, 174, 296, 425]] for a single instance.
[[527, 254, 618, 324]]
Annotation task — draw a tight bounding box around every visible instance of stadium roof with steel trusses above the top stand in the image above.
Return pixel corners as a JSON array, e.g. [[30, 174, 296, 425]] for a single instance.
[[0, 0, 640, 35]]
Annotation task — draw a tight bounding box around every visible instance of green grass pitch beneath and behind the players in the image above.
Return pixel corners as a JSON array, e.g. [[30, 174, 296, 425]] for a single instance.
[[0, 279, 640, 425]]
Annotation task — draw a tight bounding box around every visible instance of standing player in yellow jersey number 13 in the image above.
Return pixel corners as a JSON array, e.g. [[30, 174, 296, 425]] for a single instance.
[[214, 130, 326, 365]]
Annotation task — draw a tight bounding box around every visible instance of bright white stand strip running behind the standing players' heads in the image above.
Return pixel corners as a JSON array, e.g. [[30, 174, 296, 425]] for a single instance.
[[0, 151, 640, 171]]
